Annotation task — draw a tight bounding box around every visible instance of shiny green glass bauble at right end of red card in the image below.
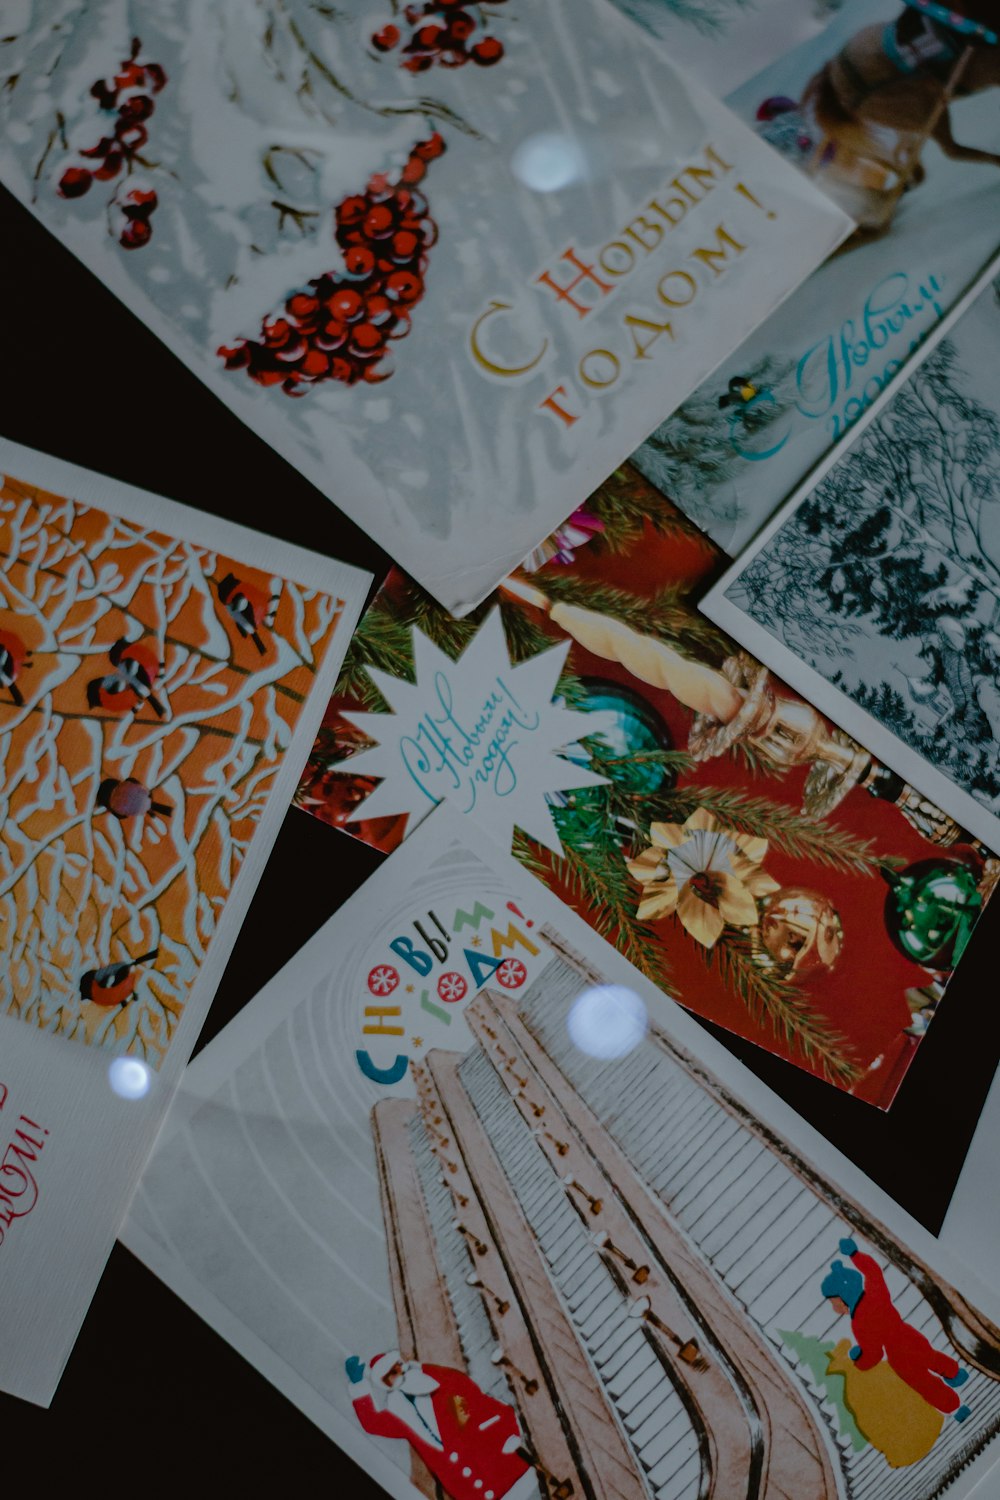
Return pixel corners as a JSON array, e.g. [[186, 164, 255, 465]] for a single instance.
[[883, 858, 982, 974]]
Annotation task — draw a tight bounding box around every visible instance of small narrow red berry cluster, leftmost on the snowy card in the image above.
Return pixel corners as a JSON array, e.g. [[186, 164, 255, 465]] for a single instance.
[[58, 36, 166, 249]]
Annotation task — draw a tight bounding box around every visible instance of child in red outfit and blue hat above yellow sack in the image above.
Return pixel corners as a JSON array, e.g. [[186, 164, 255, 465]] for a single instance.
[[822, 1239, 970, 1422]]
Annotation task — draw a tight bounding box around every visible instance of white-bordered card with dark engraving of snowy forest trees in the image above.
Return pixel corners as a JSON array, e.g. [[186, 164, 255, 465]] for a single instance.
[[703, 263, 1000, 848]]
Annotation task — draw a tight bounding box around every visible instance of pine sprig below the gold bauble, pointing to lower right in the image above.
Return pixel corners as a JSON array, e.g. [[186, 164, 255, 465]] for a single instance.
[[697, 927, 861, 1088]]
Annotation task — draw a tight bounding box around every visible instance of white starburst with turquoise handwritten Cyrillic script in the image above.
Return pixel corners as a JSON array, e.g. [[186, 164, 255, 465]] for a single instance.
[[343, 609, 613, 854]]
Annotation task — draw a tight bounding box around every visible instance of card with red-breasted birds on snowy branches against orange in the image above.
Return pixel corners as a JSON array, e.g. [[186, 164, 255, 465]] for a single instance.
[[0, 440, 369, 1404]]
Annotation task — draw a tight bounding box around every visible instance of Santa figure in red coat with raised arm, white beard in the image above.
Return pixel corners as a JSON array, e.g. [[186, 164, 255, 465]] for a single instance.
[[346, 1349, 538, 1500]]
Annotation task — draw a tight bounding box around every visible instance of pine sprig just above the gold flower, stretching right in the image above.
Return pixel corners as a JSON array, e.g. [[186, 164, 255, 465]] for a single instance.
[[665, 786, 889, 875]]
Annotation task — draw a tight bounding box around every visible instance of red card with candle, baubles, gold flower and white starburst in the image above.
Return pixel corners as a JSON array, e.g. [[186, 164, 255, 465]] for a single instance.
[[297, 468, 997, 1107]]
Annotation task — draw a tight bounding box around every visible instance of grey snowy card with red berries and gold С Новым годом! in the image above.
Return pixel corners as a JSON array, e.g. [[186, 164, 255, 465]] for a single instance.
[[0, 0, 850, 612]]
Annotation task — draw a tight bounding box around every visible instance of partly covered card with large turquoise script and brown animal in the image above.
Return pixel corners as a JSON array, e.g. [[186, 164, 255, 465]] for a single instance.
[[616, 0, 1000, 555]]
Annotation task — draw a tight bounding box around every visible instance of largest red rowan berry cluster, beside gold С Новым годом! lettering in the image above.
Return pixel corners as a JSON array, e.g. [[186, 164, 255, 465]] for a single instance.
[[219, 131, 445, 396]]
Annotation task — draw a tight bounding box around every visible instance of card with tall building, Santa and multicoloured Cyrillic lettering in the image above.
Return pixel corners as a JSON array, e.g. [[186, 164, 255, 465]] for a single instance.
[[124, 809, 1000, 1500]]
